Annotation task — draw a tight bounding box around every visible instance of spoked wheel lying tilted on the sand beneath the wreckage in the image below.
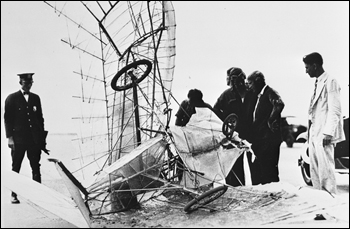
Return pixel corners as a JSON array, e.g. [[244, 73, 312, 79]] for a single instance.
[[184, 185, 227, 213]]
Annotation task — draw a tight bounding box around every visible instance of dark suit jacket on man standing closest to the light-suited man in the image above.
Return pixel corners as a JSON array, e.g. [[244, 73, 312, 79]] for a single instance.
[[252, 86, 284, 142]]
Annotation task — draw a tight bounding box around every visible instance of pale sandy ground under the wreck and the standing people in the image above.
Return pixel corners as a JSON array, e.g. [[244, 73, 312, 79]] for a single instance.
[[1, 132, 349, 228]]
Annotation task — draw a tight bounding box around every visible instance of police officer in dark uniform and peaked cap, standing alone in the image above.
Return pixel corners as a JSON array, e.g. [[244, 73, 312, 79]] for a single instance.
[[4, 73, 46, 203]]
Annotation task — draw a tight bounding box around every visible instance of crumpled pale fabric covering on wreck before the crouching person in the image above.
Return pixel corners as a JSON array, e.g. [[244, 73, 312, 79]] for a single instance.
[[170, 107, 245, 188]]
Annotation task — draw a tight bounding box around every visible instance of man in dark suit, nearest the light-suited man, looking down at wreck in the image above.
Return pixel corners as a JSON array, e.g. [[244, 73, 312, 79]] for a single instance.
[[247, 71, 284, 185]]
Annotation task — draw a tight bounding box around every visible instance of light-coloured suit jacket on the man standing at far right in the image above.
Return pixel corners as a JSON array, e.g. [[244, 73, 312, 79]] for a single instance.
[[309, 72, 345, 143]]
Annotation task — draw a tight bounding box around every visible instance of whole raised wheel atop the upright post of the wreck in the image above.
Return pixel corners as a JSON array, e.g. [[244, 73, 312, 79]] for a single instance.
[[111, 60, 152, 91]]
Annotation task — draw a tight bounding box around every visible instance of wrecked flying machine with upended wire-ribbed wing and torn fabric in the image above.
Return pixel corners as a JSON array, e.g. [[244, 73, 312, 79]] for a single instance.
[[4, 1, 278, 226]]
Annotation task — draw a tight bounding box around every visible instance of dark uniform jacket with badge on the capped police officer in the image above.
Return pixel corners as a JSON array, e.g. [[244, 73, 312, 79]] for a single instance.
[[4, 90, 44, 144]]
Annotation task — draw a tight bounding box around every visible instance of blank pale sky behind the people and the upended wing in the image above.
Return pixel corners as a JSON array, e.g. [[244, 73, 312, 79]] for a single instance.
[[1, 1, 349, 133]]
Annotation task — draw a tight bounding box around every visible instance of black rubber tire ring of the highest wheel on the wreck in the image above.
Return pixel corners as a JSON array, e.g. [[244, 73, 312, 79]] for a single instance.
[[111, 59, 152, 91]]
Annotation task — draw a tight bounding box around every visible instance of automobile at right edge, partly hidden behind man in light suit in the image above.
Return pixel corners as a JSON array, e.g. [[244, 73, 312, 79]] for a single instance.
[[297, 117, 349, 186]]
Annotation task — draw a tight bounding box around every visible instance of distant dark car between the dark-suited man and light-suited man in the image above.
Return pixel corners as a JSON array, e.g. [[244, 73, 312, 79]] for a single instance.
[[281, 116, 307, 148]]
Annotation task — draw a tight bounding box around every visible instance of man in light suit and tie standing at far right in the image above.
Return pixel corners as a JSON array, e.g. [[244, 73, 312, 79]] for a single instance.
[[303, 52, 345, 196]]
